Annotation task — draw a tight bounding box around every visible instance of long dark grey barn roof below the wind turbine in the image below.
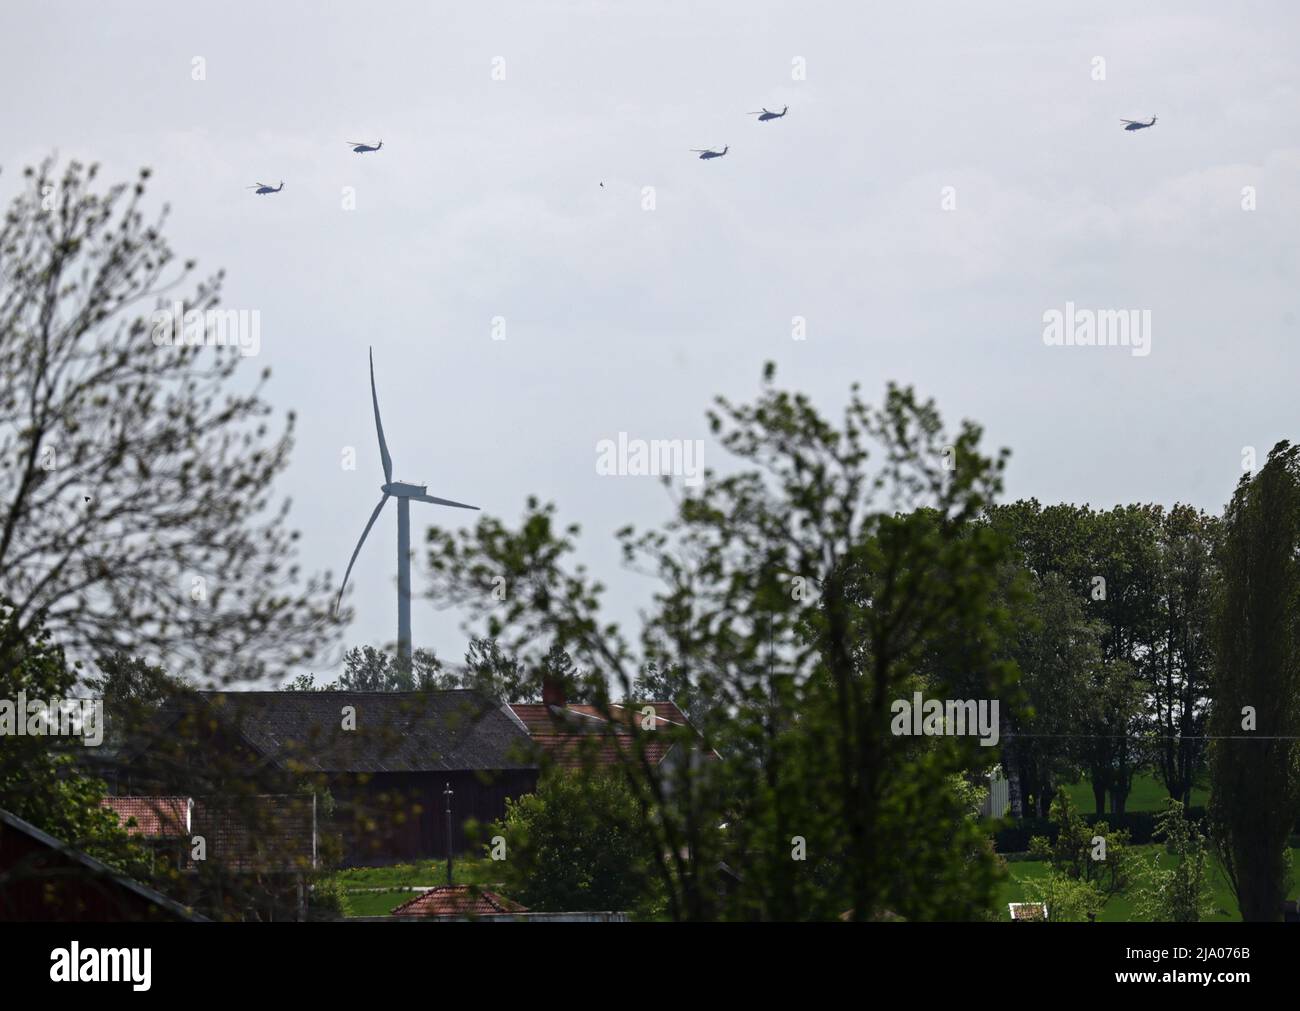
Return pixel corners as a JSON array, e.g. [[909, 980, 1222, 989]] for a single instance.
[[199, 690, 536, 772]]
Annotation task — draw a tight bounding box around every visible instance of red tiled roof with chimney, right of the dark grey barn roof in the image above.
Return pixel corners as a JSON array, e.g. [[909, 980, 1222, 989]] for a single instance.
[[510, 702, 688, 768]]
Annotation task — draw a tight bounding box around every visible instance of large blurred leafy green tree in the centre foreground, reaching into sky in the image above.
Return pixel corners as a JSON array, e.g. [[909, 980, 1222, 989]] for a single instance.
[[429, 366, 1014, 919]]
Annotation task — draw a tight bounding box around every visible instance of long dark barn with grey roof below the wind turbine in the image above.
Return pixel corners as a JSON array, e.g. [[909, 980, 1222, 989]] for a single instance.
[[108, 690, 538, 865]]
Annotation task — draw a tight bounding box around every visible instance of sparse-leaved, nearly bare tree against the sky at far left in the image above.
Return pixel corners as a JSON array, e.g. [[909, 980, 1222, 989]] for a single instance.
[[0, 160, 330, 680]]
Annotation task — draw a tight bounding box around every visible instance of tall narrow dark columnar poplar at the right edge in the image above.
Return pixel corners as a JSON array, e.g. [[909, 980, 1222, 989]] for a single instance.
[[1209, 442, 1300, 920]]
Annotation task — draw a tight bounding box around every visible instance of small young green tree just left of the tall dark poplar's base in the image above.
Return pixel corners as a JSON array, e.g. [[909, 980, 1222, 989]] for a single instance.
[[1136, 798, 1214, 923]]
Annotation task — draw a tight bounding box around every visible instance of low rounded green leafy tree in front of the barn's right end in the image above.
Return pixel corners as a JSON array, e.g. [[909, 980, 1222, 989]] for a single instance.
[[488, 768, 653, 912]]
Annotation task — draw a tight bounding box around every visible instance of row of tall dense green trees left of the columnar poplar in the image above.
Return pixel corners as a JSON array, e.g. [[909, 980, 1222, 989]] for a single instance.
[[989, 499, 1222, 816]]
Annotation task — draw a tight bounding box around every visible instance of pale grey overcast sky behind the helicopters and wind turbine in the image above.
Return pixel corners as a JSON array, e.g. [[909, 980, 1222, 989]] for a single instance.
[[0, 0, 1300, 677]]
